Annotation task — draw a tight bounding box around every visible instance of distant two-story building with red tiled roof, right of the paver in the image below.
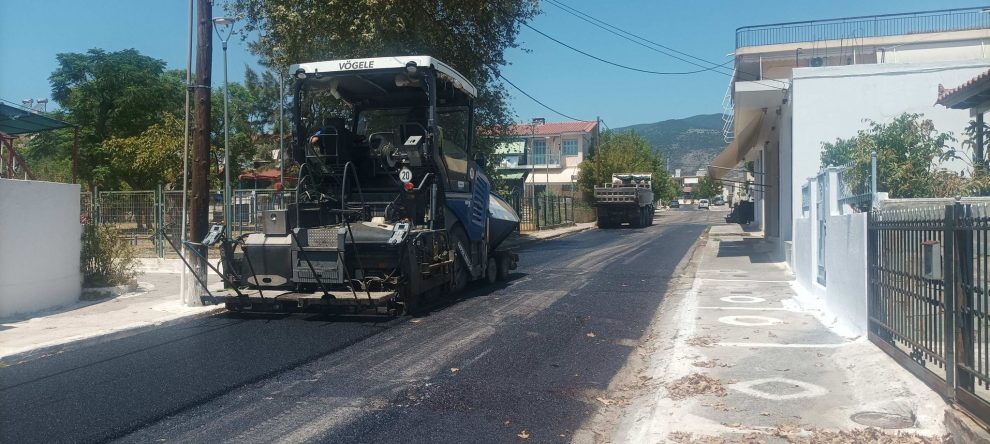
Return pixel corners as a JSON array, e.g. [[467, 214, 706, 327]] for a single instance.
[[496, 118, 598, 194]]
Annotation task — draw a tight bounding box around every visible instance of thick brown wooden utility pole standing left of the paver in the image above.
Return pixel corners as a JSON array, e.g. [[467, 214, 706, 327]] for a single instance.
[[189, 0, 213, 306]]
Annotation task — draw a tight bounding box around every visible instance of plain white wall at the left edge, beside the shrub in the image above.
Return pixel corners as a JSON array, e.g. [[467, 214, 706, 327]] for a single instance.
[[0, 179, 82, 318]]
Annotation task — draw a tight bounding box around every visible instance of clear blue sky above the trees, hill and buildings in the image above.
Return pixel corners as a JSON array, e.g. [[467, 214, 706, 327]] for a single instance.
[[0, 0, 987, 127]]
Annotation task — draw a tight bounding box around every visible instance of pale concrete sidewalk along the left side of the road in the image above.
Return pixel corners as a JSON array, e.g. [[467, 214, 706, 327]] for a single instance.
[[0, 223, 594, 365]]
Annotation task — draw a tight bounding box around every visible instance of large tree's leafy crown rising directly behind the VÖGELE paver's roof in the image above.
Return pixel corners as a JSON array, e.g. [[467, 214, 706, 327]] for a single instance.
[[230, 0, 538, 163]]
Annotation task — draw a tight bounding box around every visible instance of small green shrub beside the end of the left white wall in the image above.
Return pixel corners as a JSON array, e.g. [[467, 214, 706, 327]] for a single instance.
[[79, 222, 137, 288]]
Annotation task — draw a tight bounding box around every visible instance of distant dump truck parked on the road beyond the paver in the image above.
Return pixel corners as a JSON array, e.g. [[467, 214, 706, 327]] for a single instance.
[[594, 173, 656, 228]]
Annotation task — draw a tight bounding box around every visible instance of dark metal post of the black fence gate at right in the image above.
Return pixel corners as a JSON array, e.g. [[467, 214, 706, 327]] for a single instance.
[[942, 205, 956, 401]]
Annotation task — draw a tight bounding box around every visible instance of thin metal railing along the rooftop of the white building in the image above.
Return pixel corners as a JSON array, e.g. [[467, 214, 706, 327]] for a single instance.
[[736, 8, 990, 48]]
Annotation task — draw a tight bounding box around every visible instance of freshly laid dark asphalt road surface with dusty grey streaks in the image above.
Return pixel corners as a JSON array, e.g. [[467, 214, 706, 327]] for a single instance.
[[0, 210, 725, 443]]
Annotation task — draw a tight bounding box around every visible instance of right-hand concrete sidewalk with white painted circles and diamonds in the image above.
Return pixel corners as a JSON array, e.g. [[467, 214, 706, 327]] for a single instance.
[[602, 225, 946, 443]]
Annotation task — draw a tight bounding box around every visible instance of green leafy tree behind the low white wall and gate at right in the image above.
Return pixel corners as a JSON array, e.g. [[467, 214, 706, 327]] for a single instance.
[[821, 113, 966, 198]]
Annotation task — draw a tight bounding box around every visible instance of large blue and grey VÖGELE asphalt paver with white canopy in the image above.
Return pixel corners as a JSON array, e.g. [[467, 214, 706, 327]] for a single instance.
[[204, 56, 519, 314]]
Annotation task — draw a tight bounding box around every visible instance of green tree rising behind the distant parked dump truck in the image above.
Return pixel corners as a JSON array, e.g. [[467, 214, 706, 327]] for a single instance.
[[578, 131, 677, 200]]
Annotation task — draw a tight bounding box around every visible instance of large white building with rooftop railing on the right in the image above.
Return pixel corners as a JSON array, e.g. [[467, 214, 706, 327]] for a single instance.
[[709, 8, 990, 266]]
